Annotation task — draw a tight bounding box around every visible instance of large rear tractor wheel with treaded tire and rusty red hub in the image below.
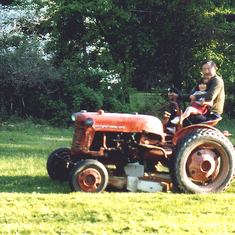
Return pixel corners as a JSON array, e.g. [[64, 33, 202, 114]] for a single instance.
[[171, 129, 235, 193]]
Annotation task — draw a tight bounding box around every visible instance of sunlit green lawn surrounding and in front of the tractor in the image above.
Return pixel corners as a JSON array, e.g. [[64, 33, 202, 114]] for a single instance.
[[0, 120, 235, 235]]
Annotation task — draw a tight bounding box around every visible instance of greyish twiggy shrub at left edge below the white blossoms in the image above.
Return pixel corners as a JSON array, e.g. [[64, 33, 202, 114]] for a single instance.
[[0, 37, 60, 117]]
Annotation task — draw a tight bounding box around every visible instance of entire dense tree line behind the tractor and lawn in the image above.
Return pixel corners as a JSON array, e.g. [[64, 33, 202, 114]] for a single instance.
[[0, 0, 235, 125]]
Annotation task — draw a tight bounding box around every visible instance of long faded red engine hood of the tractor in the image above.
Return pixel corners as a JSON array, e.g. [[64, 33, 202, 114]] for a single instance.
[[72, 110, 163, 136]]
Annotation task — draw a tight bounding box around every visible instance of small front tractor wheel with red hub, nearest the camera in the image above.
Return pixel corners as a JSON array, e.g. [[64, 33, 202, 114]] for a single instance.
[[69, 159, 109, 193]]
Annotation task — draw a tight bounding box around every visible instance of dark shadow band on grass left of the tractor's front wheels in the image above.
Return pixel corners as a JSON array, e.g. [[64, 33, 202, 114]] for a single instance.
[[0, 176, 71, 194]]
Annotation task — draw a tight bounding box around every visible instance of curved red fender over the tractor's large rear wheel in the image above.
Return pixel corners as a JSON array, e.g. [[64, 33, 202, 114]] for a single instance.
[[172, 124, 219, 145]]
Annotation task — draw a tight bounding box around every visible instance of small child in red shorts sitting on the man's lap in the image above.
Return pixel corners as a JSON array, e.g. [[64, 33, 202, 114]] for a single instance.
[[171, 78, 213, 124]]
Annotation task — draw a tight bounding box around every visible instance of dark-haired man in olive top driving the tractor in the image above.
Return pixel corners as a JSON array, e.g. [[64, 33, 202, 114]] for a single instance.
[[168, 60, 225, 126]]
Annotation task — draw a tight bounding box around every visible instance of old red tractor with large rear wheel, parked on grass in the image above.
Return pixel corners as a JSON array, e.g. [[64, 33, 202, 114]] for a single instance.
[[47, 95, 235, 193]]
